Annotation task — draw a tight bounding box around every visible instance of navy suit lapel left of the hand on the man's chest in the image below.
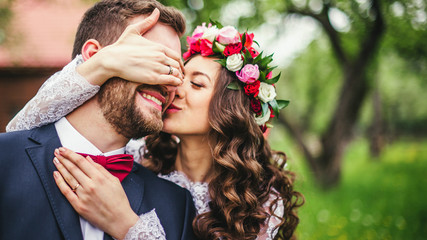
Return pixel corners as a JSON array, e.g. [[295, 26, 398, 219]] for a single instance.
[[26, 124, 83, 240]]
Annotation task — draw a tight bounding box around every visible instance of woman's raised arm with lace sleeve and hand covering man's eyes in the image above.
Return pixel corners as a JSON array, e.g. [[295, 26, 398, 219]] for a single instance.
[[6, 10, 183, 132]]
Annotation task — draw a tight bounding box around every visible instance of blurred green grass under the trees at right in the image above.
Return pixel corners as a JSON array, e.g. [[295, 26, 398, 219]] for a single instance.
[[272, 131, 427, 240]]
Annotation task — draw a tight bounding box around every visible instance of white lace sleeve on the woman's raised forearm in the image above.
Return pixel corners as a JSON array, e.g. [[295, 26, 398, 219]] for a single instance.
[[6, 55, 100, 132]]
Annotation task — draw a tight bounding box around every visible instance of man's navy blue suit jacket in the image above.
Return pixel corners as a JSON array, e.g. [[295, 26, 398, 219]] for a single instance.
[[0, 124, 195, 240]]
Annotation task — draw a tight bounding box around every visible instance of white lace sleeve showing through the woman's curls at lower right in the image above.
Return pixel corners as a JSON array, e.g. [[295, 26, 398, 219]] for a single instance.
[[257, 194, 285, 240]]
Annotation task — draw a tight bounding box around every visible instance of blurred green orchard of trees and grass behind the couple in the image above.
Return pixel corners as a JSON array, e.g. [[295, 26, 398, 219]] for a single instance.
[[0, 0, 427, 240]]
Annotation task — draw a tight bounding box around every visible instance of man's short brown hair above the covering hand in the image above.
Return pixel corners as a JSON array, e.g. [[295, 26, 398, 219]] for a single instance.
[[72, 0, 185, 58]]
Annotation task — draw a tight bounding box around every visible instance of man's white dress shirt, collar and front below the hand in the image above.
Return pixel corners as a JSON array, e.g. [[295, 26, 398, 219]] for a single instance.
[[55, 117, 125, 240]]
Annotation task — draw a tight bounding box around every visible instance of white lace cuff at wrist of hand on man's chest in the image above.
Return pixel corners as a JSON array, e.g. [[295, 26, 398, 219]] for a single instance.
[[124, 209, 166, 240]]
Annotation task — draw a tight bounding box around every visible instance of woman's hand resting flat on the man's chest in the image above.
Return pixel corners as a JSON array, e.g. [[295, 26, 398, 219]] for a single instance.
[[53, 147, 139, 239]]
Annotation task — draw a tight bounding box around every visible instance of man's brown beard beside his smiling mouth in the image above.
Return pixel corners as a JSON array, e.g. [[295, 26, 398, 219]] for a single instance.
[[98, 78, 163, 139]]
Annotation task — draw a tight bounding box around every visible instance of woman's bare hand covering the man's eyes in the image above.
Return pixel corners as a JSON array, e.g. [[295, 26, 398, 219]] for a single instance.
[[77, 9, 184, 89]]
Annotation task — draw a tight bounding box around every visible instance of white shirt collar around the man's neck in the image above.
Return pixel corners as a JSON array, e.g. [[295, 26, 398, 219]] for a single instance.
[[55, 117, 125, 156]]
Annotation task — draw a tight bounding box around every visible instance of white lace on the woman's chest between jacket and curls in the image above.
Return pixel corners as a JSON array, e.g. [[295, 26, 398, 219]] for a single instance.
[[159, 171, 211, 215]]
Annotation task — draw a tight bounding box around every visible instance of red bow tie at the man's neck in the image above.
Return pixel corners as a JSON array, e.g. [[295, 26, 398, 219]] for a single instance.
[[78, 153, 133, 182]]
